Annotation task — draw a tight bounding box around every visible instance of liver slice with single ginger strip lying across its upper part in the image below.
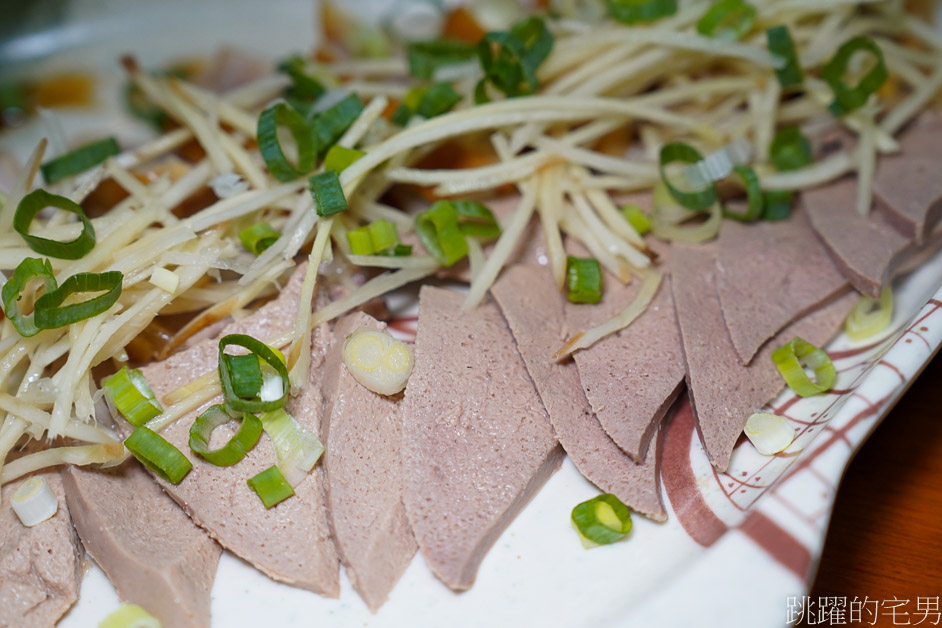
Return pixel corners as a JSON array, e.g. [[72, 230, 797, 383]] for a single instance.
[[565, 241, 684, 462]]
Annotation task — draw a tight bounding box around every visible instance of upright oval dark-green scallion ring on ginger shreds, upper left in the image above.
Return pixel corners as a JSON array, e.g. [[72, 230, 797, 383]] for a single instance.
[[257, 102, 318, 181]]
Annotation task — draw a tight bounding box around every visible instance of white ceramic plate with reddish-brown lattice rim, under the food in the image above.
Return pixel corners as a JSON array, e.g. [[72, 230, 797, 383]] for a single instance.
[[0, 0, 942, 628]]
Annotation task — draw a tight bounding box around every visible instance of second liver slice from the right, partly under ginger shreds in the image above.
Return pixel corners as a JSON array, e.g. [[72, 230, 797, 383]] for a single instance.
[[801, 179, 910, 298]]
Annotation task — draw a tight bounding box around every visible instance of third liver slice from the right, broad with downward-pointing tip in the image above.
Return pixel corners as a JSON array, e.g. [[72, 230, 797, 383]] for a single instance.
[[716, 211, 847, 364]]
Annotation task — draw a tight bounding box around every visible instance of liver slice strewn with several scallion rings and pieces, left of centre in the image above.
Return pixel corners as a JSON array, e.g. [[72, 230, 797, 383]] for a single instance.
[[142, 270, 340, 597]]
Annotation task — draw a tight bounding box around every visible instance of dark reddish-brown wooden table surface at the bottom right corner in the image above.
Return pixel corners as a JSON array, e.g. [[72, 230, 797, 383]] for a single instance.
[[810, 355, 942, 626]]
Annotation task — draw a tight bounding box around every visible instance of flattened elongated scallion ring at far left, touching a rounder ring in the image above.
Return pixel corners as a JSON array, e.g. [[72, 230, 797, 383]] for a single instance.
[[33, 270, 124, 329]]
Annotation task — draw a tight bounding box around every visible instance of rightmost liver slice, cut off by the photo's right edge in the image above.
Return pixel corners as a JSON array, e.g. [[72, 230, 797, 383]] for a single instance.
[[873, 156, 942, 244]]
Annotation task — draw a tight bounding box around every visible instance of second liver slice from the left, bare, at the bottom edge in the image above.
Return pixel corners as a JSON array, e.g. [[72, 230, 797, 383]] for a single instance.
[[62, 459, 222, 628]]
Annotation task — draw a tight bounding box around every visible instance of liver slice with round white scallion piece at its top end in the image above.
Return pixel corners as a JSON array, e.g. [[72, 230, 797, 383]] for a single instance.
[[323, 313, 416, 612]]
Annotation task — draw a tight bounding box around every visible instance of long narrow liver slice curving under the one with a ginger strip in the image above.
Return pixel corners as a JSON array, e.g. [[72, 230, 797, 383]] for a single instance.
[[491, 265, 668, 521]]
